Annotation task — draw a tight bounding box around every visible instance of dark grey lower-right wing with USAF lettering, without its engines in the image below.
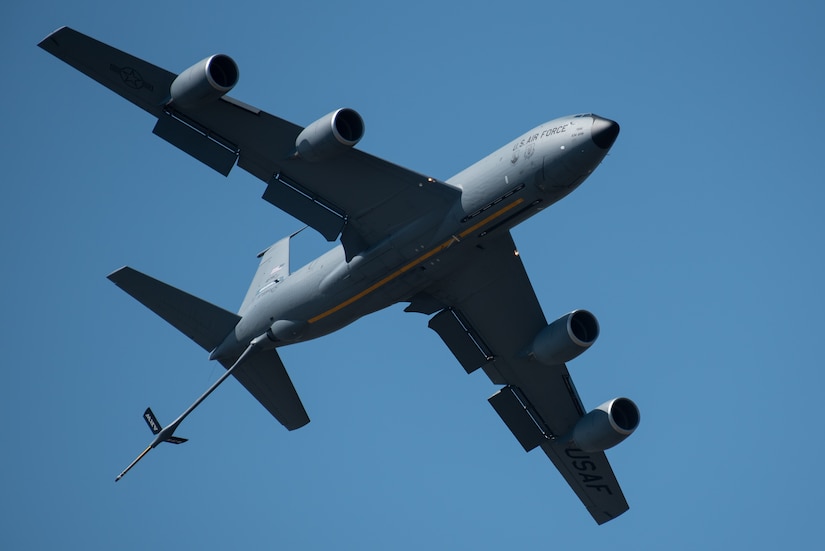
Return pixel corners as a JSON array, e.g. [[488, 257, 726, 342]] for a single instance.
[[427, 233, 628, 524]]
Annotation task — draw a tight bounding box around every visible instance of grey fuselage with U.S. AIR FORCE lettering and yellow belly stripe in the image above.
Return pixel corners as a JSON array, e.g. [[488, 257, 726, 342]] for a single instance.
[[211, 114, 619, 359]]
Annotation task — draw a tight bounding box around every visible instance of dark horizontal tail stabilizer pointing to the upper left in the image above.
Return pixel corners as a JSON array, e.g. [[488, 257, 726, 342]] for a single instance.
[[108, 266, 241, 352]]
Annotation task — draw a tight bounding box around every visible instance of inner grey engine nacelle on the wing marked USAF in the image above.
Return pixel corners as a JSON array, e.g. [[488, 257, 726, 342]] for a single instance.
[[529, 310, 599, 365]]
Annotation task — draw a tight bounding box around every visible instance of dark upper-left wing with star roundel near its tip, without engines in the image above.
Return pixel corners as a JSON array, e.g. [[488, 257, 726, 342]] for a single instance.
[[39, 27, 460, 257]]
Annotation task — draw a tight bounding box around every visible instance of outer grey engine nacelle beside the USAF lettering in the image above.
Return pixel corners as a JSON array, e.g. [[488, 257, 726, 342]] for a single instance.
[[573, 398, 640, 452]]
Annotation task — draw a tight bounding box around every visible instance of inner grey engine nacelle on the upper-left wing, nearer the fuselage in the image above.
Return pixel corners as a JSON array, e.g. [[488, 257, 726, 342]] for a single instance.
[[295, 109, 364, 162]]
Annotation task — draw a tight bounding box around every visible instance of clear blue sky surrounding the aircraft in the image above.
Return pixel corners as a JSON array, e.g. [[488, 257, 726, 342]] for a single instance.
[[0, 0, 825, 549]]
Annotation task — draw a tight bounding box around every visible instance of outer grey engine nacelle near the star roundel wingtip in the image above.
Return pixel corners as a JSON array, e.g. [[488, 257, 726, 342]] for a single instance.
[[170, 54, 238, 107]]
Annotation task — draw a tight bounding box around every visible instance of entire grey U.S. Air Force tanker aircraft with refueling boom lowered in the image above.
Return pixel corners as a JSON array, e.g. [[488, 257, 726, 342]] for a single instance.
[[39, 27, 640, 524]]
